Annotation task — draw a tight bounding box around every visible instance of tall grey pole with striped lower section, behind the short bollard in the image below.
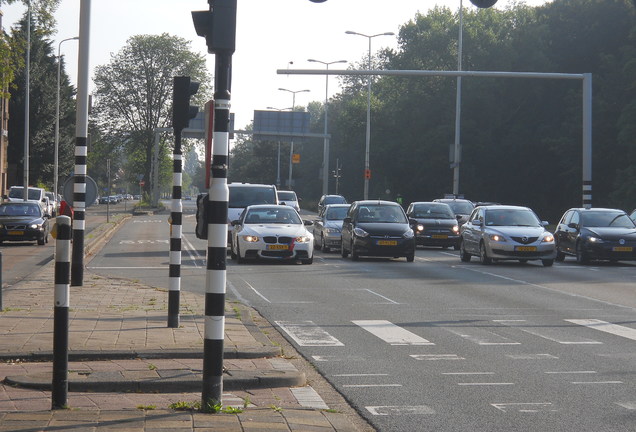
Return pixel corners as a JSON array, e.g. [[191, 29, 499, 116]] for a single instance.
[[71, 0, 91, 286]]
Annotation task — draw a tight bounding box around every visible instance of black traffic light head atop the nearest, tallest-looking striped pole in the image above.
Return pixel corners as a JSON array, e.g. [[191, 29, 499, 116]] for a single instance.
[[192, 0, 236, 53]]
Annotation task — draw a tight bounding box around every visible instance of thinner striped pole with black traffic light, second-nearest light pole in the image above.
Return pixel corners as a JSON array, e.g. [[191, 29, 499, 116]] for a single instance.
[[168, 76, 199, 328]]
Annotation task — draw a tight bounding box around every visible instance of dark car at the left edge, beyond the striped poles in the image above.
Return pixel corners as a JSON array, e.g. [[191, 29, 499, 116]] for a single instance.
[[0, 202, 49, 245]]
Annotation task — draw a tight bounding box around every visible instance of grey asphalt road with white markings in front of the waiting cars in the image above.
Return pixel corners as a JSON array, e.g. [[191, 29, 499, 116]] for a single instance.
[[88, 207, 636, 432]]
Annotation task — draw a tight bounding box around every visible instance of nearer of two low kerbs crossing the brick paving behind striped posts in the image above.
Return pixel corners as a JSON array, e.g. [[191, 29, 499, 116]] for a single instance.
[[4, 369, 307, 393]]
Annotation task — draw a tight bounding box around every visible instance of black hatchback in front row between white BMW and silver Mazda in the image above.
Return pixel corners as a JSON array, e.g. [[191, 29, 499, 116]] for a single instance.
[[341, 201, 415, 262]]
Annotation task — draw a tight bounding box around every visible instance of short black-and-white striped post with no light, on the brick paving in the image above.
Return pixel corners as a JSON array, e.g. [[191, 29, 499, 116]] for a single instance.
[[51, 216, 71, 409]]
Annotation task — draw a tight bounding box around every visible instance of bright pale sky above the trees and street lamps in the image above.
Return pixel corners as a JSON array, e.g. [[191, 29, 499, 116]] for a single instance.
[[2, 0, 551, 129]]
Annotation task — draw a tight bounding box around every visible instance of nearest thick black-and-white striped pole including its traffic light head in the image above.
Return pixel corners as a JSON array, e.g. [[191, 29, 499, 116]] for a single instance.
[[192, 0, 237, 410]]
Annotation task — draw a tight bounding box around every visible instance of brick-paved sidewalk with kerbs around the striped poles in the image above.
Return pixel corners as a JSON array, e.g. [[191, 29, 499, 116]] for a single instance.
[[0, 215, 372, 432]]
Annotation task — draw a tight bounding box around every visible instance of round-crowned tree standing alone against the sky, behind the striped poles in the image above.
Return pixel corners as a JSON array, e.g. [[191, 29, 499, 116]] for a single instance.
[[94, 33, 210, 195]]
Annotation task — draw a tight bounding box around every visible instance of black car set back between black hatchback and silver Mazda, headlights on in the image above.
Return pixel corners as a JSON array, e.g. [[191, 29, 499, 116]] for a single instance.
[[406, 201, 459, 250]]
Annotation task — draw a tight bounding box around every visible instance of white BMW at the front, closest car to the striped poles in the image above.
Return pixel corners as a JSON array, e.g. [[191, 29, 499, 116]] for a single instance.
[[230, 204, 314, 264]]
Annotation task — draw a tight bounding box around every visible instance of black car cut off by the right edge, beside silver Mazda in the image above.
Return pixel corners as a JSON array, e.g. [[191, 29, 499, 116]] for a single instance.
[[554, 208, 636, 264]]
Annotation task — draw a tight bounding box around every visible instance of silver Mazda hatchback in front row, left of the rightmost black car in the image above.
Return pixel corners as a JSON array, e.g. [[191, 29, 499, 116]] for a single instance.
[[459, 205, 556, 267]]
